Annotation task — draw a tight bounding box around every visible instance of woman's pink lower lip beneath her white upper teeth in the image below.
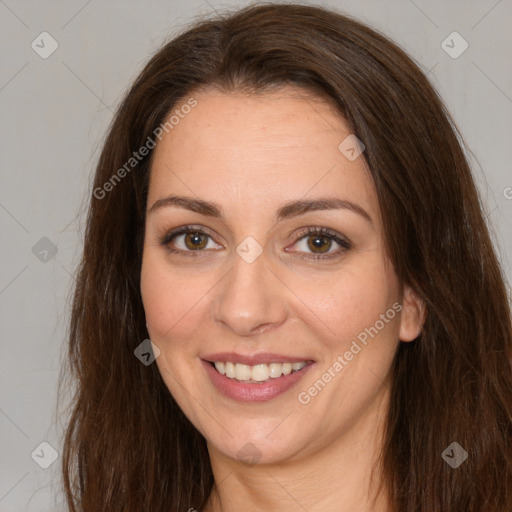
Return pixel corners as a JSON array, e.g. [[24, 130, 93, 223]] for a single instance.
[[201, 360, 314, 402]]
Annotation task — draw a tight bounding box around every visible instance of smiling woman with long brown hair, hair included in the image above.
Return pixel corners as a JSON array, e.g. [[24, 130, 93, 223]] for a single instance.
[[63, 4, 512, 512]]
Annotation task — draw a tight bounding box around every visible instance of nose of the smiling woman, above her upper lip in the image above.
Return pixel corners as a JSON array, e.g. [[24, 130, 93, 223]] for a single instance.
[[212, 247, 288, 336]]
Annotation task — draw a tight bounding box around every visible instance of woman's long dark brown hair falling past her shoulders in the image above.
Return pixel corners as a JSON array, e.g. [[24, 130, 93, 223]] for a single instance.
[[63, 3, 512, 512]]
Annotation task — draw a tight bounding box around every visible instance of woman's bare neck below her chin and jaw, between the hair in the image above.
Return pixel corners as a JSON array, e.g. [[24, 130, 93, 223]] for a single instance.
[[203, 388, 391, 512]]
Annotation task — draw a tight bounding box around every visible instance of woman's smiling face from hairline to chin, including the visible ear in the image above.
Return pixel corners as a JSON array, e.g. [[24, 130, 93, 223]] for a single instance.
[[141, 87, 420, 463]]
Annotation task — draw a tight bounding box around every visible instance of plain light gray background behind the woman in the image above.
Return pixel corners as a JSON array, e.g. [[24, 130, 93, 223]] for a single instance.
[[0, 0, 512, 512]]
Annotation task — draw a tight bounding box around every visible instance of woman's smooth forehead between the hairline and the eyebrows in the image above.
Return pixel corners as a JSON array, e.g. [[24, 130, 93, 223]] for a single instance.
[[148, 86, 378, 224]]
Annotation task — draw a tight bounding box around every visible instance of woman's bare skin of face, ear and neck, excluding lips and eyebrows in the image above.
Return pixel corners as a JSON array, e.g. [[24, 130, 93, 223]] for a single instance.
[[141, 87, 424, 512]]
